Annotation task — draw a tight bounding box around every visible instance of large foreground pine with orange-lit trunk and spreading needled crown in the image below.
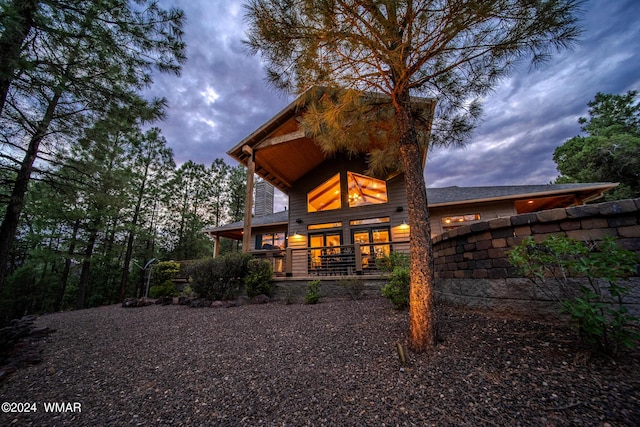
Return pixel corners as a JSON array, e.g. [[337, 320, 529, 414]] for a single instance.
[[247, 0, 580, 351]]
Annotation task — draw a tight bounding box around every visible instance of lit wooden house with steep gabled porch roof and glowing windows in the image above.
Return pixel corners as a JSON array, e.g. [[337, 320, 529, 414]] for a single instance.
[[205, 89, 616, 278]]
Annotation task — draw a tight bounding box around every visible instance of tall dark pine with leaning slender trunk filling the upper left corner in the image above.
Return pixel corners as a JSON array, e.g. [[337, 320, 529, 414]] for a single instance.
[[0, 0, 184, 289]]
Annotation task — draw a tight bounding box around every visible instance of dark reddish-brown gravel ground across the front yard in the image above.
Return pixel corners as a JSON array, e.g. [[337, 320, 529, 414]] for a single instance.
[[0, 298, 640, 426]]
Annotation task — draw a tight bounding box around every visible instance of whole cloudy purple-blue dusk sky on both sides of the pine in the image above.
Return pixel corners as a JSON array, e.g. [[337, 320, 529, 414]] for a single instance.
[[149, 0, 640, 208]]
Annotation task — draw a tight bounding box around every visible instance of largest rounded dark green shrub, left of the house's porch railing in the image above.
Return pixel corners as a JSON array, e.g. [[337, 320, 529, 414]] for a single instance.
[[189, 253, 251, 300]]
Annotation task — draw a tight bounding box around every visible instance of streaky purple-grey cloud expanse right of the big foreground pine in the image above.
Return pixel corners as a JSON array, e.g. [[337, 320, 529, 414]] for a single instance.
[[425, 0, 640, 187]]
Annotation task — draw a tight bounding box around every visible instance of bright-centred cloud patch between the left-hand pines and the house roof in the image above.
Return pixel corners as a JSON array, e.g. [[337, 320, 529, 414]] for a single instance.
[[148, 0, 287, 164]]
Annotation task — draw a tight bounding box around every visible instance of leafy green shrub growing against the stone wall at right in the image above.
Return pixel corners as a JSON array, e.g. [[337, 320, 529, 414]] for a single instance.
[[509, 236, 640, 355]]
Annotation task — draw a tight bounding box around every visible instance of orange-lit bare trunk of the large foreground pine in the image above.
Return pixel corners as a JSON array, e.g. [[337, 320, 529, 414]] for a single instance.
[[394, 93, 436, 352]]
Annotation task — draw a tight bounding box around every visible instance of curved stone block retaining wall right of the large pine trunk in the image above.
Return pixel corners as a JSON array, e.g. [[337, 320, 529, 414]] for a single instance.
[[433, 199, 640, 314]]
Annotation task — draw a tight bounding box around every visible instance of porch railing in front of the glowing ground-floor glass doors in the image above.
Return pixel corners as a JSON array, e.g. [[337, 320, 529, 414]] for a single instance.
[[251, 242, 408, 277]]
